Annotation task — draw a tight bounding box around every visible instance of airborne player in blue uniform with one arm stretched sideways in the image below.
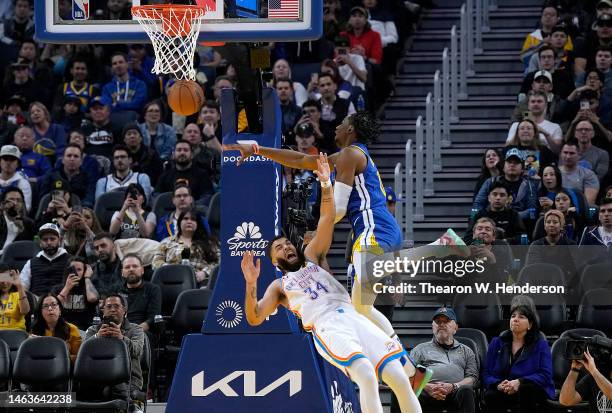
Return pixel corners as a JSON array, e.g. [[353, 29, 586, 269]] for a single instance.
[[224, 112, 463, 386]]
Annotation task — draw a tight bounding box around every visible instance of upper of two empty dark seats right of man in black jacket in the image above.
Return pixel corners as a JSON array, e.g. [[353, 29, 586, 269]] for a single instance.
[[151, 264, 196, 315]]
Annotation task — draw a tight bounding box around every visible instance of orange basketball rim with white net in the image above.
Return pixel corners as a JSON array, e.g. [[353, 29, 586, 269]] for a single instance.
[[132, 4, 206, 80]]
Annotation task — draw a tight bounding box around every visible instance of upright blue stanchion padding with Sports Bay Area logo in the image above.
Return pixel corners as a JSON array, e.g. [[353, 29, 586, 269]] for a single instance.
[[202, 88, 298, 334]]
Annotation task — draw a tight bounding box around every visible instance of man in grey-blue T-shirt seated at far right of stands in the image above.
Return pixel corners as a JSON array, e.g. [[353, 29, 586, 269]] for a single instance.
[[559, 139, 599, 205]]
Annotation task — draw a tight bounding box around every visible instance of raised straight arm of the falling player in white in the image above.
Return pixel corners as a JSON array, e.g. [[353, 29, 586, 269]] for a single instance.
[[304, 153, 336, 265]]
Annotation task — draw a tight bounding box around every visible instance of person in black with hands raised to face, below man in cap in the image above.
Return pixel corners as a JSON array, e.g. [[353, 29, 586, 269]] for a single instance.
[[53, 257, 98, 331]]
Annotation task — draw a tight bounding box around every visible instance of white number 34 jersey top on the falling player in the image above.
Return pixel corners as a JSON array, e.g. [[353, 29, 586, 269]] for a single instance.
[[281, 262, 352, 328]]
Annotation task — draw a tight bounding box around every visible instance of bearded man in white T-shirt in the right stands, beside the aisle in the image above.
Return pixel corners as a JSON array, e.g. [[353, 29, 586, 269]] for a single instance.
[[506, 91, 563, 153]]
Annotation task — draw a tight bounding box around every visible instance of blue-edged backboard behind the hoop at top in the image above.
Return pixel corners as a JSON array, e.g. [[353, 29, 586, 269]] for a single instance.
[[34, 0, 323, 43]]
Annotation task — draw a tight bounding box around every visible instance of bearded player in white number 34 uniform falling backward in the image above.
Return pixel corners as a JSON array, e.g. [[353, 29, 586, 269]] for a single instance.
[[241, 154, 421, 413]]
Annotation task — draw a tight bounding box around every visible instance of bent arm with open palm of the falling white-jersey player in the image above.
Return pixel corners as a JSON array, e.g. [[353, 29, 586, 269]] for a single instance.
[[240, 251, 283, 326]]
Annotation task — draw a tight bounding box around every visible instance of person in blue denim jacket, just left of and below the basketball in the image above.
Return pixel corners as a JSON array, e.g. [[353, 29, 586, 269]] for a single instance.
[[138, 100, 176, 160]]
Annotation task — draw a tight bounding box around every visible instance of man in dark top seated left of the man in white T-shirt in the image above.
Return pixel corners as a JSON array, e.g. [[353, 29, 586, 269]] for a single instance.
[[41, 144, 96, 208]]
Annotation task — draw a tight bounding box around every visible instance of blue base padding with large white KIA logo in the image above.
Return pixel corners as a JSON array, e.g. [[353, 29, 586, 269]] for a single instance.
[[166, 333, 361, 413]]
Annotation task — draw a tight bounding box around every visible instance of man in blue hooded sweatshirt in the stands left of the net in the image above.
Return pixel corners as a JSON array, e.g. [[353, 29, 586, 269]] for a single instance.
[[102, 52, 147, 113]]
